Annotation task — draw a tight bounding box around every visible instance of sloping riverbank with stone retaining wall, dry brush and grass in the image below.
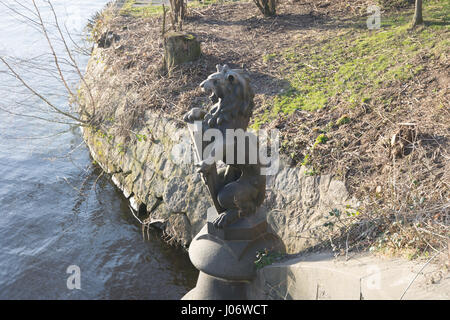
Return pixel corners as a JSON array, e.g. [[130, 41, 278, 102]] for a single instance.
[[80, 1, 450, 264]]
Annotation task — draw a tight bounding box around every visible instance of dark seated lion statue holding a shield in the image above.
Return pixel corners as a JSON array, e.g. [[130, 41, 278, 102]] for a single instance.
[[183, 65, 266, 228]]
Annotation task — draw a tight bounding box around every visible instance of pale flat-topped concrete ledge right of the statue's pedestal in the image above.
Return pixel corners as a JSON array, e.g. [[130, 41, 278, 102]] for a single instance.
[[248, 253, 450, 300]]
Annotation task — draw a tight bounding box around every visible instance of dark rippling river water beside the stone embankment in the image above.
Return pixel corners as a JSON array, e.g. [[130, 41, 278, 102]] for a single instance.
[[0, 0, 197, 299]]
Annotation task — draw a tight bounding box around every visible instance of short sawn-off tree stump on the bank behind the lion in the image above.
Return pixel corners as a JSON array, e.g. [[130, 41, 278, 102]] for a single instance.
[[164, 32, 201, 72]]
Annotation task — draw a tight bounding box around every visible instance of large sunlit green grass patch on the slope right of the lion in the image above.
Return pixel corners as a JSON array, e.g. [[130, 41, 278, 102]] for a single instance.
[[253, 1, 450, 128]]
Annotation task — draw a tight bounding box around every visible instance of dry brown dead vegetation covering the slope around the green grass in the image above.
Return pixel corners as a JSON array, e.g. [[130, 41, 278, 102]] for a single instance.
[[86, 0, 450, 257]]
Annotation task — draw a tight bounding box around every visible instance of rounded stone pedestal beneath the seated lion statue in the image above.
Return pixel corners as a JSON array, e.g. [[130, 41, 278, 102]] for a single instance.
[[182, 208, 285, 300]]
